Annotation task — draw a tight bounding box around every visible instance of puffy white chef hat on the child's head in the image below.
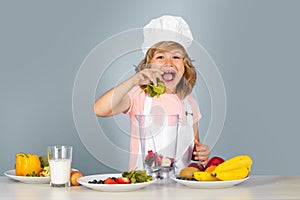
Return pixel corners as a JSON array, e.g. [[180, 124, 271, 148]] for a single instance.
[[142, 15, 193, 54]]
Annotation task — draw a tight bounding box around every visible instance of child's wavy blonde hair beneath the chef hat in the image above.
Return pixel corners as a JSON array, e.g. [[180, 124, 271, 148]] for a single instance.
[[135, 41, 197, 99]]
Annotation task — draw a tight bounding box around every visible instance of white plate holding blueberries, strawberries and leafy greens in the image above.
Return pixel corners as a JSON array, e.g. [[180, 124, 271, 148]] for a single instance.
[[77, 174, 155, 192]]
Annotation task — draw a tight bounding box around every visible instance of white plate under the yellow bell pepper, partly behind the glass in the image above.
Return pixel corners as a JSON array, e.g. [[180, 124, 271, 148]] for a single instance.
[[4, 169, 50, 183]]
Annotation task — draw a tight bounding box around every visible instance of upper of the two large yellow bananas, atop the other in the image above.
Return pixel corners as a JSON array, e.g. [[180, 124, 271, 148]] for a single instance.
[[213, 155, 252, 173]]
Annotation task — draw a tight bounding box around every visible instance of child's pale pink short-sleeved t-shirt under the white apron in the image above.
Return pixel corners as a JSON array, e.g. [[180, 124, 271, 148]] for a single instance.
[[127, 87, 201, 170]]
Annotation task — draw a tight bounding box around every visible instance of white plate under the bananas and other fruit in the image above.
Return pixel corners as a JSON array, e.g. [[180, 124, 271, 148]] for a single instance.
[[172, 177, 249, 189]]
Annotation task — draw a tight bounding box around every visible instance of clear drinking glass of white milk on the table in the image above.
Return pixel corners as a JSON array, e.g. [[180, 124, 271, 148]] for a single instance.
[[47, 146, 72, 187]]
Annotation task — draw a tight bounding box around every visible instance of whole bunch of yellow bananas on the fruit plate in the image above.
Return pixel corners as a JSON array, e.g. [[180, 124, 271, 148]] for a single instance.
[[194, 155, 252, 181]]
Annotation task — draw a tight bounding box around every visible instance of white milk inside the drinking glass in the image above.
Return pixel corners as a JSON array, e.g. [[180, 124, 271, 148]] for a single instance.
[[49, 159, 71, 184]]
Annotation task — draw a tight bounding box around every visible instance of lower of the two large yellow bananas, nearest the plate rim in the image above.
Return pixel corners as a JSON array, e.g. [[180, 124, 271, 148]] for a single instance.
[[212, 167, 250, 181]]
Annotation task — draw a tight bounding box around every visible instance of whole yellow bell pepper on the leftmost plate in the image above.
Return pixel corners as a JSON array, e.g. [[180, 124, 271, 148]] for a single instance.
[[15, 153, 41, 176]]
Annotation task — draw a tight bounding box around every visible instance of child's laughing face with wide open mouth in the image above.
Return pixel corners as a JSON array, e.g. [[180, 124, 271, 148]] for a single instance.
[[150, 50, 184, 93]]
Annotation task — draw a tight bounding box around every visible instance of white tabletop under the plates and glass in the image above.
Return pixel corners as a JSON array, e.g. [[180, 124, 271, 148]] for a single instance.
[[0, 176, 300, 200]]
